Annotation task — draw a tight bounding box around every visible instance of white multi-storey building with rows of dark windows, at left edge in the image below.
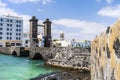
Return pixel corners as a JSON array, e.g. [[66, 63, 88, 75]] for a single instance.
[[0, 15, 23, 47]]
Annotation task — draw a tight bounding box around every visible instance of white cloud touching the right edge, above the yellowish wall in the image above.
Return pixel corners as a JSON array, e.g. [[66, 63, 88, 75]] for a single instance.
[[98, 5, 120, 18]]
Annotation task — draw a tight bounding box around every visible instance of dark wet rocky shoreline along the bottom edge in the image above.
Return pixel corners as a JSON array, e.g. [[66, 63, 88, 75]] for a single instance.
[[30, 69, 90, 80]]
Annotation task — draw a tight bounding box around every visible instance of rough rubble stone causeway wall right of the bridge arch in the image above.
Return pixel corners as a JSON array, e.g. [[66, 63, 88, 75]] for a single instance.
[[46, 47, 90, 70]]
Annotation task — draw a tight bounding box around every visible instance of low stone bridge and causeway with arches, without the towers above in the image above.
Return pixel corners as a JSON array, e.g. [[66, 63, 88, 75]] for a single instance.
[[0, 47, 90, 70]]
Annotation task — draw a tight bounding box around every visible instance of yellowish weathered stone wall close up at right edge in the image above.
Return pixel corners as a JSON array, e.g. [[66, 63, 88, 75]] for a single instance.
[[91, 20, 120, 80]]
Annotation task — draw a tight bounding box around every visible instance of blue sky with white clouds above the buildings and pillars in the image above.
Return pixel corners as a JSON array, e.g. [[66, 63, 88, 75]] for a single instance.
[[0, 0, 120, 40]]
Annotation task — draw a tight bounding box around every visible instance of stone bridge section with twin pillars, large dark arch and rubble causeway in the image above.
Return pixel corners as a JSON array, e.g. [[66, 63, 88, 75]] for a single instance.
[[29, 16, 90, 70]]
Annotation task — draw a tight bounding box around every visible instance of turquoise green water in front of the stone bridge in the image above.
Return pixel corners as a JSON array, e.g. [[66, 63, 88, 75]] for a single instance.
[[0, 54, 55, 80]]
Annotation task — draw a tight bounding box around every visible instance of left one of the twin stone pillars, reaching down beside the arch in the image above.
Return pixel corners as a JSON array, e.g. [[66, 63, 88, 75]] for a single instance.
[[30, 16, 38, 58]]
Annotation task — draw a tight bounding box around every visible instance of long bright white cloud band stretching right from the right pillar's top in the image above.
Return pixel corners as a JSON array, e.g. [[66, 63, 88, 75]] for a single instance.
[[53, 19, 104, 34]]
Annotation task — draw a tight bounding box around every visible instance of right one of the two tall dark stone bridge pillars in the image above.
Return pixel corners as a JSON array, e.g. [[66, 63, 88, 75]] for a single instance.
[[43, 19, 52, 47]]
